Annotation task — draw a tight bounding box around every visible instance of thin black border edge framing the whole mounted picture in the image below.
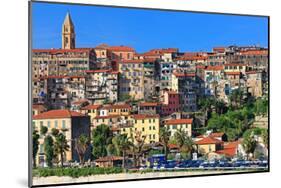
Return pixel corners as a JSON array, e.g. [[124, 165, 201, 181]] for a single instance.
[[28, 0, 271, 187]]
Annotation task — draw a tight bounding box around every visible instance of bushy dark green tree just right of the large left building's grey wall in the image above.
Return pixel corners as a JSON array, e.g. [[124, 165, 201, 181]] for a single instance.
[[92, 124, 112, 159]]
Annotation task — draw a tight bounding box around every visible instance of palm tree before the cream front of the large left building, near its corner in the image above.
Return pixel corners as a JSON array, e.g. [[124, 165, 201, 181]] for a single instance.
[[54, 133, 69, 167]]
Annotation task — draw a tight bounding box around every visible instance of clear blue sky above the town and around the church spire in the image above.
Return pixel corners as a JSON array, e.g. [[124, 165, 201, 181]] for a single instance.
[[32, 2, 268, 52]]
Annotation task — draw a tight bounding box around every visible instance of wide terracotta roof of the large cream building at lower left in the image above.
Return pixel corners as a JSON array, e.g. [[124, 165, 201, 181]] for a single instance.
[[33, 110, 85, 119]]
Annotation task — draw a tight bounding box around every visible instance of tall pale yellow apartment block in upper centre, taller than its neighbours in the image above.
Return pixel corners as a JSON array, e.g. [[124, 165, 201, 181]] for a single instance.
[[119, 59, 144, 100]]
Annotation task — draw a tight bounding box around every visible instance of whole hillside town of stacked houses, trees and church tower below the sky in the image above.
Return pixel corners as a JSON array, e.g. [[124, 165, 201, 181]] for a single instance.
[[31, 13, 269, 175]]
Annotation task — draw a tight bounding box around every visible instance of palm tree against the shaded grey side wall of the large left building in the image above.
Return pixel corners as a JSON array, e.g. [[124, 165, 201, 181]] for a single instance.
[[75, 134, 89, 165]]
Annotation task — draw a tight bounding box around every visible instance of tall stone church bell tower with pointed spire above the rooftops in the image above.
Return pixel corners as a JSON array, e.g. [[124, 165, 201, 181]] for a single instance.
[[62, 12, 75, 49]]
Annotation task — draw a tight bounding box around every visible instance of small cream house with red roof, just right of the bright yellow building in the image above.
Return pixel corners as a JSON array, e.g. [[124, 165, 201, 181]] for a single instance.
[[164, 119, 193, 137]]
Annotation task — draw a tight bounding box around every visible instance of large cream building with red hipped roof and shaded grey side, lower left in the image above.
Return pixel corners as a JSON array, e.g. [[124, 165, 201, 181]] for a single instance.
[[32, 110, 90, 166]]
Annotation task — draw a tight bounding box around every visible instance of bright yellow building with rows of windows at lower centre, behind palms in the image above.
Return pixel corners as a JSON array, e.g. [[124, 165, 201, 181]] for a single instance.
[[121, 114, 160, 144]]
